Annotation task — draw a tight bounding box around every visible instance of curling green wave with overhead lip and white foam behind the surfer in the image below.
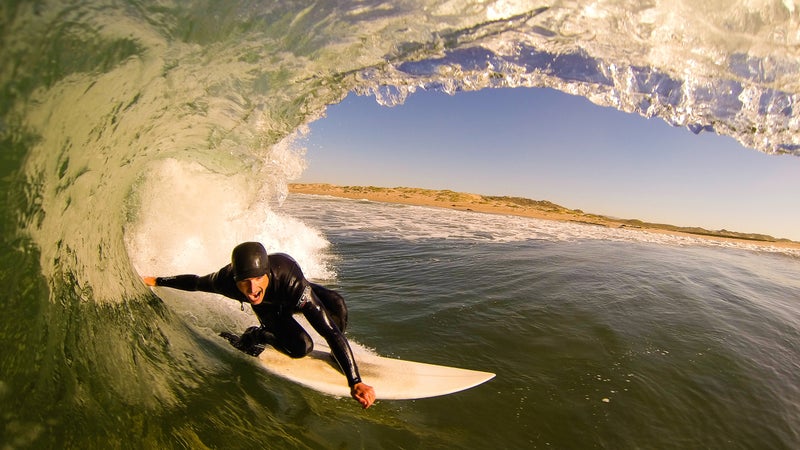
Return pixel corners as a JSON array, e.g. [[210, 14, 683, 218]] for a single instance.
[[0, 0, 800, 444]]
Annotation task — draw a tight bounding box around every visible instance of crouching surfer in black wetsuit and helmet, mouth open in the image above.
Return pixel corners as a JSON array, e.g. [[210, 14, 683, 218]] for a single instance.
[[143, 242, 375, 408]]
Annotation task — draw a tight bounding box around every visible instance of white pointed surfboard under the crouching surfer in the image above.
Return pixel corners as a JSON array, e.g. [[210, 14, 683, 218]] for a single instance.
[[258, 341, 495, 400]]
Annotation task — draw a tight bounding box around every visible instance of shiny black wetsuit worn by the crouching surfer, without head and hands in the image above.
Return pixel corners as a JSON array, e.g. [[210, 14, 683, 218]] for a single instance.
[[156, 253, 361, 387]]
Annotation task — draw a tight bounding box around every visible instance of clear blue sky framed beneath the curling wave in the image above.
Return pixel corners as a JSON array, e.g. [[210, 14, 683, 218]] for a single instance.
[[298, 89, 800, 241]]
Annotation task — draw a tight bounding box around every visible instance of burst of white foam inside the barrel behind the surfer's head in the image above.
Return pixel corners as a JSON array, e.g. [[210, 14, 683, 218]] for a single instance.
[[126, 159, 333, 278]]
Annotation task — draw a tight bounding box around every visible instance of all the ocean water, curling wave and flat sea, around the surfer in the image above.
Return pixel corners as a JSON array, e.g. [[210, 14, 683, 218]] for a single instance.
[[0, 0, 800, 449]]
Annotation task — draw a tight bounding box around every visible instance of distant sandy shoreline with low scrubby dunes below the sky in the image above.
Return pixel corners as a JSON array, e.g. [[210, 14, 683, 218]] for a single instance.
[[289, 183, 800, 249]]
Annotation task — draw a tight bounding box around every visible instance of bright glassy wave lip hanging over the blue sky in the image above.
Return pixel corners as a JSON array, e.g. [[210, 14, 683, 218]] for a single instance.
[[358, 1, 800, 155]]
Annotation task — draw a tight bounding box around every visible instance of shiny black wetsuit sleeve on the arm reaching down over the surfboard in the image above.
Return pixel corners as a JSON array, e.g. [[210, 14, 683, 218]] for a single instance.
[[299, 286, 361, 387]]
